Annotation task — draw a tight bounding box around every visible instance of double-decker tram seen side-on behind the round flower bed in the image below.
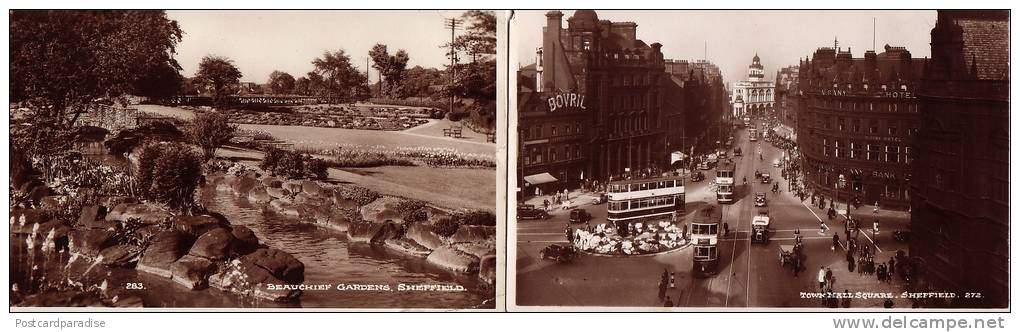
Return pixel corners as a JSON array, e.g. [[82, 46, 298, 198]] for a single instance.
[[608, 175, 686, 225]]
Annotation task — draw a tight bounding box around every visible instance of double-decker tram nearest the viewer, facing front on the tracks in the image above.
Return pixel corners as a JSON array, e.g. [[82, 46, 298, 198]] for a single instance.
[[690, 205, 722, 278]]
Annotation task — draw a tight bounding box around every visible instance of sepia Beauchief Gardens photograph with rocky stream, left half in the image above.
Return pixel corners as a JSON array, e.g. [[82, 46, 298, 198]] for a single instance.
[[7, 10, 505, 312]]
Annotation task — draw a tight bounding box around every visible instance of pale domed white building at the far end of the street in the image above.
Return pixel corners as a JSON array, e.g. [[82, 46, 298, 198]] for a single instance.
[[729, 54, 775, 118]]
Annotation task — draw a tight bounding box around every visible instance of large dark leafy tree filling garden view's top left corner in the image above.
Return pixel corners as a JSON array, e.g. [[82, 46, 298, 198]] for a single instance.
[[9, 10, 182, 127]]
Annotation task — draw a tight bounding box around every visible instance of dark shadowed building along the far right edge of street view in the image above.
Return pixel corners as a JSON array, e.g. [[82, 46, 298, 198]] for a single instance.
[[910, 10, 1010, 307]]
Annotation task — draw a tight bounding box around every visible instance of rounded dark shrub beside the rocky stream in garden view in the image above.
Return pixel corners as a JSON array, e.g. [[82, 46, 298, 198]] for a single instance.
[[136, 143, 202, 210]]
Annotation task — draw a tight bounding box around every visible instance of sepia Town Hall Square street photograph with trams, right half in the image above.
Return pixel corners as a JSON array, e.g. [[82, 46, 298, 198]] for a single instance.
[[507, 10, 1011, 312]]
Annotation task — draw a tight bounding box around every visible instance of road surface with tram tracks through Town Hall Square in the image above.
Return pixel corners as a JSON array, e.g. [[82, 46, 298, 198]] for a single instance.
[[511, 124, 910, 309]]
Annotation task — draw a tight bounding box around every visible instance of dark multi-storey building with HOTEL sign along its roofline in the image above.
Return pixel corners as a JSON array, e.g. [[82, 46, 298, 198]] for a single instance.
[[797, 45, 924, 209]]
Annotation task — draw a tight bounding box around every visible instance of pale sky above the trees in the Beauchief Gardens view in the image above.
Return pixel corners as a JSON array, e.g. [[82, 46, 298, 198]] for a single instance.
[[166, 10, 463, 83]]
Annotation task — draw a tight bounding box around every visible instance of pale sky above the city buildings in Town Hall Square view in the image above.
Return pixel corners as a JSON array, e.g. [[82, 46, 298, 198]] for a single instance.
[[511, 10, 936, 83]]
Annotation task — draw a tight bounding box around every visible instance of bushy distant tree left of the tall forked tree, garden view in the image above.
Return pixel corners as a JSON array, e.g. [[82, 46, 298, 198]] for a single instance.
[[309, 50, 368, 100]]
